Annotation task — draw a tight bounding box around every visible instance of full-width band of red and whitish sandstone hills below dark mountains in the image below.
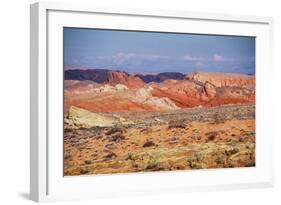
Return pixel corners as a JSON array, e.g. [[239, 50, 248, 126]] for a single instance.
[[64, 71, 255, 112]]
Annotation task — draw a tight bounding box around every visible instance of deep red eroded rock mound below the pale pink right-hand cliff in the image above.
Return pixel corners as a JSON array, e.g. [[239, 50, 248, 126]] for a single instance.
[[151, 77, 255, 108]]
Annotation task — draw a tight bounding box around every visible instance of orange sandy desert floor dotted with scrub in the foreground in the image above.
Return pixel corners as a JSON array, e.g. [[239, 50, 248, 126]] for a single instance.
[[64, 104, 255, 176]]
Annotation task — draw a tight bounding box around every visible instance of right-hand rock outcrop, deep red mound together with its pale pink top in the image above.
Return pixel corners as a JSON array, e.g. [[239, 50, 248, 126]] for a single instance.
[[152, 73, 255, 108]]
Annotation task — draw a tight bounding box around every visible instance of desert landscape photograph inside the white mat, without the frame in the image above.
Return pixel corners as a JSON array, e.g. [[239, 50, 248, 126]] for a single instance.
[[61, 27, 256, 176]]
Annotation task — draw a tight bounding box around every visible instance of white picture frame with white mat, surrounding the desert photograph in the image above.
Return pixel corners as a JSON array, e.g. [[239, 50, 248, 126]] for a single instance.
[[30, 2, 273, 202]]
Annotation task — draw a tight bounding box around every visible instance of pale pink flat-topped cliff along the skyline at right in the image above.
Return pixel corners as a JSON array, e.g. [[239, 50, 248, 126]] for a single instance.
[[186, 72, 255, 88]]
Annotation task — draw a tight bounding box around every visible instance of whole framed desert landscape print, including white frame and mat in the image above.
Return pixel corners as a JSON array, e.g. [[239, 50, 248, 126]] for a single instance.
[[30, 3, 273, 201]]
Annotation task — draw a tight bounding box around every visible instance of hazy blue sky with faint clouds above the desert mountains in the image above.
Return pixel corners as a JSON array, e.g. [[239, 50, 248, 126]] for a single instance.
[[64, 28, 255, 73]]
